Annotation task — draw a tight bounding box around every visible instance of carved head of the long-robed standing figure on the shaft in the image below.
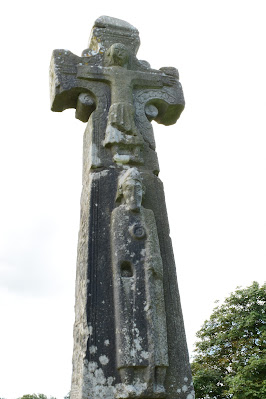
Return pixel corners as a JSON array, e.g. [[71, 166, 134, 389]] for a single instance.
[[117, 168, 144, 212]]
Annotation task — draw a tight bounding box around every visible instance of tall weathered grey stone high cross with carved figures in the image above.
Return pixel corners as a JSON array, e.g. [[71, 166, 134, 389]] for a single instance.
[[50, 16, 194, 399]]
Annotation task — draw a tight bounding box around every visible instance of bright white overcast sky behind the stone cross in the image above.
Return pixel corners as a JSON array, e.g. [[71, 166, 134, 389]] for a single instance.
[[0, 0, 266, 399]]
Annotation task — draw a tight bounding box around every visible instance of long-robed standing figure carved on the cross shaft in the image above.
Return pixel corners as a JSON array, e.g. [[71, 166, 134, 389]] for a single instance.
[[111, 168, 168, 396]]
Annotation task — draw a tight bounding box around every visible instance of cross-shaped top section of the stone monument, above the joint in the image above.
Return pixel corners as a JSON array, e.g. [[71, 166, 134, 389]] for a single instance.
[[50, 17, 184, 171]]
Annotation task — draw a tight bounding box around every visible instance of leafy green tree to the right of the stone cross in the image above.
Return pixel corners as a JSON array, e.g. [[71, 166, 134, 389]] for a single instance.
[[191, 282, 266, 399]]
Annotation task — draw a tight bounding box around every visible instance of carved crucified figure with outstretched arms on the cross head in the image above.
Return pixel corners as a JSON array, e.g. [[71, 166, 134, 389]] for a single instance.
[[60, 43, 177, 164]]
